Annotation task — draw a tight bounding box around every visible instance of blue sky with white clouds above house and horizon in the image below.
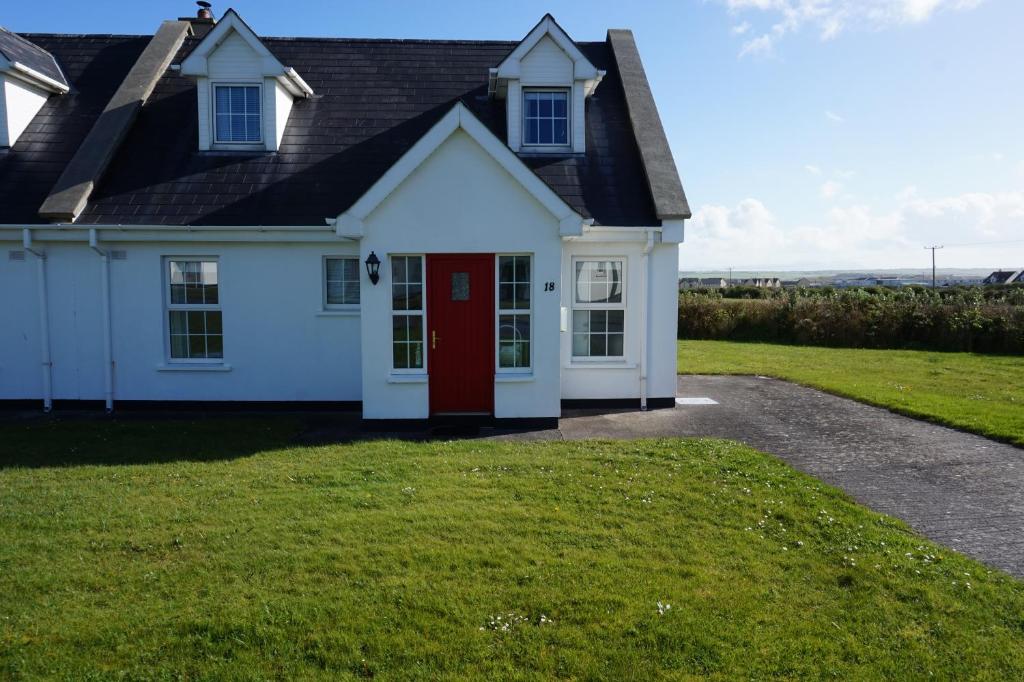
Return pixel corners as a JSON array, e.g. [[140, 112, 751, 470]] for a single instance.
[[8, 0, 1024, 270]]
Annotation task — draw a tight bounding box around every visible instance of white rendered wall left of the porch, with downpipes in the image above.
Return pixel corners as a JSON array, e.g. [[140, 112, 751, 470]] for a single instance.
[[0, 237, 361, 401]]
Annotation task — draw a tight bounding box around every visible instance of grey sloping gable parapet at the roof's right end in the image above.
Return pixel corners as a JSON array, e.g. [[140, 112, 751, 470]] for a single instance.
[[608, 29, 692, 220]]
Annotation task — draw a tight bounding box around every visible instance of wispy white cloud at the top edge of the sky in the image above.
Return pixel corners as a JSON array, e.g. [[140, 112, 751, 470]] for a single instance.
[[718, 0, 985, 56]]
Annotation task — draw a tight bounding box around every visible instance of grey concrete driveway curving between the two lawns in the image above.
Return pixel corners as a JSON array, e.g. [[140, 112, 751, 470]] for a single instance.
[[512, 376, 1024, 577]]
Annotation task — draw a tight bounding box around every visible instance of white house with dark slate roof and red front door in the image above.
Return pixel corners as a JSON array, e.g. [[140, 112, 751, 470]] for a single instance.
[[0, 10, 690, 420]]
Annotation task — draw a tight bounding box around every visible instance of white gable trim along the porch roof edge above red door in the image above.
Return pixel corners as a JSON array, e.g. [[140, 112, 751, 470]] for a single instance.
[[336, 102, 583, 239]]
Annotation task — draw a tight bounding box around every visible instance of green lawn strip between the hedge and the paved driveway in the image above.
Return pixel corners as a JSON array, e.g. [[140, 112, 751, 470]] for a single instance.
[[679, 341, 1024, 445]]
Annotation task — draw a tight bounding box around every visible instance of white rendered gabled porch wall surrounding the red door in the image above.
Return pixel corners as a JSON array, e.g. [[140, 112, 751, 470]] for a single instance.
[[360, 124, 561, 419]]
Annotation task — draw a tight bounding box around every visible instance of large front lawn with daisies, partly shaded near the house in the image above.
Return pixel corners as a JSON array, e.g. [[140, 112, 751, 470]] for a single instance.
[[0, 419, 1024, 680]]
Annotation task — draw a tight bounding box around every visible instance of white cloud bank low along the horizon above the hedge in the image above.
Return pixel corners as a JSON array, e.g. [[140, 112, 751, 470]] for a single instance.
[[680, 187, 1024, 271]]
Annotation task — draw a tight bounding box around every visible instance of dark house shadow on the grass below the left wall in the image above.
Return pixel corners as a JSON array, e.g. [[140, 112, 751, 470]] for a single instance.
[[0, 416, 302, 469]]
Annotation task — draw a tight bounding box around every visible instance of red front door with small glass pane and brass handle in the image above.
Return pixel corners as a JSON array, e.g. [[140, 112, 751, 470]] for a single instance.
[[427, 254, 495, 415]]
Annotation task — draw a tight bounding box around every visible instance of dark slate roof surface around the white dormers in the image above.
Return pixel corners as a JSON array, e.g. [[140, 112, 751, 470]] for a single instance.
[[0, 35, 658, 225]]
